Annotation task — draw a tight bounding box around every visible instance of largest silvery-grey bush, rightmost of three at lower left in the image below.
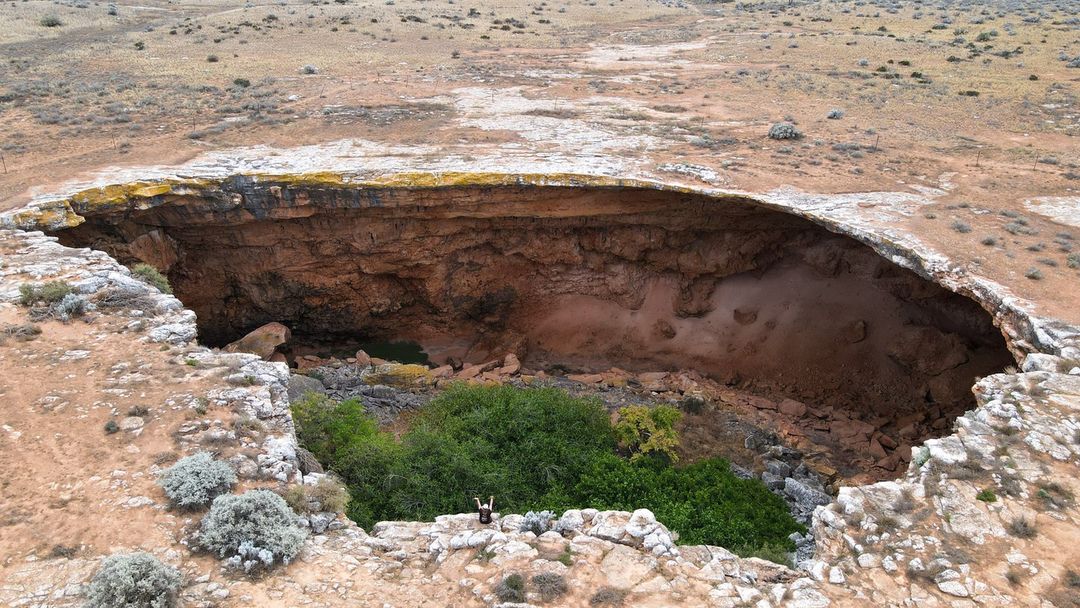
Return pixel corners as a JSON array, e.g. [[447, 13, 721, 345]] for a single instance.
[[197, 489, 306, 572]]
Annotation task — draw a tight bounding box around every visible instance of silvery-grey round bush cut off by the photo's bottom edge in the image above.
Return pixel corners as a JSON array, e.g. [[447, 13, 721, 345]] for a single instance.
[[86, 553, 180, 608]]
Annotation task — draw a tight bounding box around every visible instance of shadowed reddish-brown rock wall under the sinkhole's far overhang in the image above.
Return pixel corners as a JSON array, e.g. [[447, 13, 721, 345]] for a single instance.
[[50, 178, 1013, 481]]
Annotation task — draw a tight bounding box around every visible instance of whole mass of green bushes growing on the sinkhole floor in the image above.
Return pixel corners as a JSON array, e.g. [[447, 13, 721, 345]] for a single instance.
[[293, 386, 802, 555]]
